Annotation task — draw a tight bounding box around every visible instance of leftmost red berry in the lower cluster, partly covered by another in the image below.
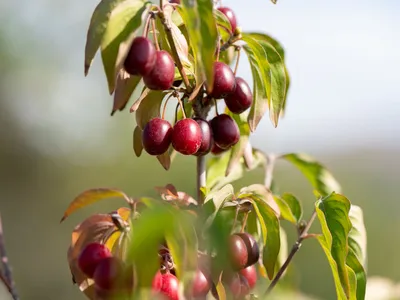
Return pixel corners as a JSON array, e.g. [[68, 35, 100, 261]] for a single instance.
[[78, 243, 112, 278]]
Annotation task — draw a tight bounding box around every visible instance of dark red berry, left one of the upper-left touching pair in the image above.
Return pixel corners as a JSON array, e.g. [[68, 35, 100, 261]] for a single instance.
[[124, 36, 156, 76]]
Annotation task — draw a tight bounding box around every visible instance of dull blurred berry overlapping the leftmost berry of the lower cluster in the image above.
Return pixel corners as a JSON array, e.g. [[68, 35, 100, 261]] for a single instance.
[[93, 257, 124, 290]]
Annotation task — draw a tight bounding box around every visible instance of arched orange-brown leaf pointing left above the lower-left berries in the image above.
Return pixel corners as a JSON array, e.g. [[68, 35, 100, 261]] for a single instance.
[[61, 188, 130, 222]]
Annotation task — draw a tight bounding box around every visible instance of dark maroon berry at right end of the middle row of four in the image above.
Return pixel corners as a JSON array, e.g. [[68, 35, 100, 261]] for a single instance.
[[211, 114, 240, 149]]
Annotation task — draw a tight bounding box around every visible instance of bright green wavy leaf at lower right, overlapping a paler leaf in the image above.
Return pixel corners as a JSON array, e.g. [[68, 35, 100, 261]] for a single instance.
[[315, 193, 353, 299]]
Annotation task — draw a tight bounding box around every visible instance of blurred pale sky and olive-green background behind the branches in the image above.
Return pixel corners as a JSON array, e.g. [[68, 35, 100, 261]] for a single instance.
[[0, 0, 400, 300]]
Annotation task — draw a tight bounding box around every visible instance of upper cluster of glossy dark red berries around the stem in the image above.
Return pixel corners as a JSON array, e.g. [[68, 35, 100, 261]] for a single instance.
[[124, 1, 253, 156]]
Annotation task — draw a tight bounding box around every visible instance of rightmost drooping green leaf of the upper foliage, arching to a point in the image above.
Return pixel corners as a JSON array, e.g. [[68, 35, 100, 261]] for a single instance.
[[244, 34, 286, 127]]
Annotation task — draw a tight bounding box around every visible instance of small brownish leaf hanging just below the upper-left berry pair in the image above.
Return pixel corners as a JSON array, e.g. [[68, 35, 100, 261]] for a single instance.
[[111, 69, 141, 116]]
